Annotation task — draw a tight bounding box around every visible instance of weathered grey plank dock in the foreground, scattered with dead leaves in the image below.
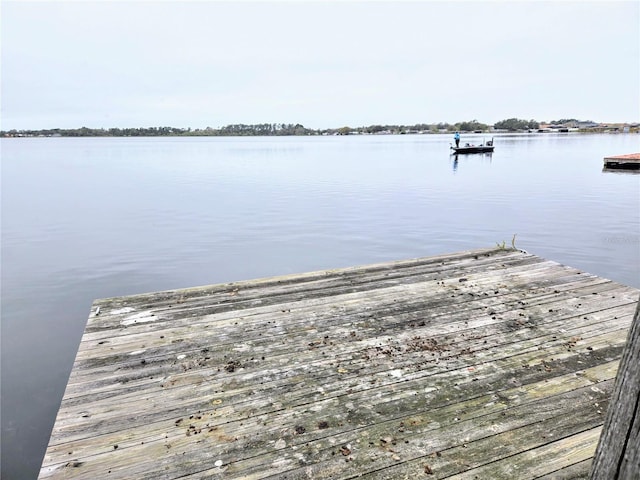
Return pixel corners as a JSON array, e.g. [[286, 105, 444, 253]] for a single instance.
[[39, 249, 640, 479]]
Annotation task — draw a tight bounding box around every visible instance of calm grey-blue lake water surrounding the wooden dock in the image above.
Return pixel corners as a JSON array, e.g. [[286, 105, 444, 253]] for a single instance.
[[1, 134, 640, 480]]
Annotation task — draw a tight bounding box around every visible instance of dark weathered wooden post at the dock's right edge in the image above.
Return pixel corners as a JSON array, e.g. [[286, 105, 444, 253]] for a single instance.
[[590, 294, 640, 480]]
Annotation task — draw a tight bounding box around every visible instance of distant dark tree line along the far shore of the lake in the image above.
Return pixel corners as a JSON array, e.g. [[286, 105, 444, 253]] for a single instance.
[[0, 118, 596, 137]]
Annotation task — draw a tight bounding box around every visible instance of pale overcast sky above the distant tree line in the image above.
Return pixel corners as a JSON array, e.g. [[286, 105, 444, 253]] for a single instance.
[[0, 0, 640, 130]]
